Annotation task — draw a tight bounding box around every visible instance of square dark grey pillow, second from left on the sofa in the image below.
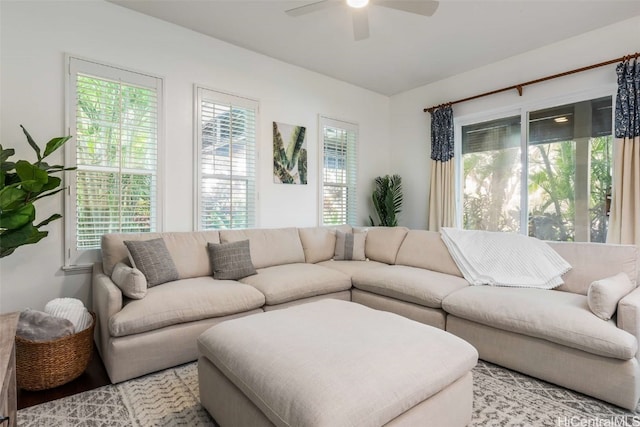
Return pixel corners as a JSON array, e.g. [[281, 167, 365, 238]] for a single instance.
[[207, 240, 257, 280]]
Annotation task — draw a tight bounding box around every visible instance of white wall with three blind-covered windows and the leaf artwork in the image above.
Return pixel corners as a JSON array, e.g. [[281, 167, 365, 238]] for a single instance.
[[0, 0, 390, 313]]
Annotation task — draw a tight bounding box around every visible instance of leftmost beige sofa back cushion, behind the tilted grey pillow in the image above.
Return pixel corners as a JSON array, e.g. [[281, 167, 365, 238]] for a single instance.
[[102, 231, 220, 279]]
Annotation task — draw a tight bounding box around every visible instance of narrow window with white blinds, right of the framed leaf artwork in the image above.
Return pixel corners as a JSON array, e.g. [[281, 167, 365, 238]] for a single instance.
[[320, 117, 358, 225]]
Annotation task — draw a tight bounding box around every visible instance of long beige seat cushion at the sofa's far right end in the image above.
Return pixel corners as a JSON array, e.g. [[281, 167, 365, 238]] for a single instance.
[[442, 286, 638, 360]]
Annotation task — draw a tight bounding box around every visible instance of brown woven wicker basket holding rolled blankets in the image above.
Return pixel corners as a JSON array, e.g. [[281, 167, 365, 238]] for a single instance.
[[16, 312, 96, 391]]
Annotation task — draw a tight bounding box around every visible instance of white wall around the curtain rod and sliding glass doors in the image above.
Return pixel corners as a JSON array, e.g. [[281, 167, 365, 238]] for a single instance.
[[391, 17, 640, 228]]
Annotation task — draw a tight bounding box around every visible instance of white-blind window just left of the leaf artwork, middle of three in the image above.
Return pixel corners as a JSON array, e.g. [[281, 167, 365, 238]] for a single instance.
[[196, 87, 258, 230]]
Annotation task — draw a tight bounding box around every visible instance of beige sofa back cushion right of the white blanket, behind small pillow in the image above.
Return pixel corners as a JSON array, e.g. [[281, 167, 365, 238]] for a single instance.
[[547, 242, 640, 295]]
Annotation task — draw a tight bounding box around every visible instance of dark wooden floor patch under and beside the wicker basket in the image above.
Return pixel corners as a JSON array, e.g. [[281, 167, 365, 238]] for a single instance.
[[18, 348, 111, 409]]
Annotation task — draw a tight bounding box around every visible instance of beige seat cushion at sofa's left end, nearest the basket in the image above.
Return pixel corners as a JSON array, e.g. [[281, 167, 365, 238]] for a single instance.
[[109, 277, 265, 337]]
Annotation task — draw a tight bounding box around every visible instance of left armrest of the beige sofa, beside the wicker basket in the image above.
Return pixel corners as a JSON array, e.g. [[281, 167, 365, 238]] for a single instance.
[[92, 262, 122, 358]]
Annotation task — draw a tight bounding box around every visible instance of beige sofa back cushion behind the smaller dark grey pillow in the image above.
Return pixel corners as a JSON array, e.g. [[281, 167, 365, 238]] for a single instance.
[[220, 228, 304, 268]]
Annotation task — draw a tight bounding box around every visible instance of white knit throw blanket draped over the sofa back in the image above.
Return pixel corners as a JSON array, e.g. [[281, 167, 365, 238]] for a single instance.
[[440, 228, 571, 289]]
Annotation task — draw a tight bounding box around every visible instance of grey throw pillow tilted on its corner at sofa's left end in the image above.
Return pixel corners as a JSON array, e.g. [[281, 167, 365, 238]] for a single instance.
[[124, 238, 180, 287]]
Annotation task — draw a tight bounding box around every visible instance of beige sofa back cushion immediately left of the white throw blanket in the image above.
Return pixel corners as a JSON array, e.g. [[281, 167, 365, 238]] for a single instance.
[[396, 230, 462, 277]]
